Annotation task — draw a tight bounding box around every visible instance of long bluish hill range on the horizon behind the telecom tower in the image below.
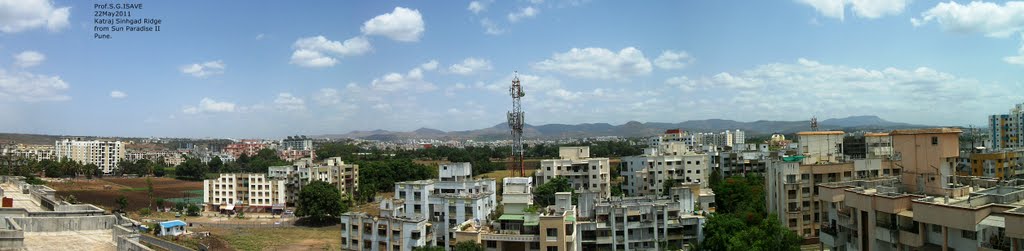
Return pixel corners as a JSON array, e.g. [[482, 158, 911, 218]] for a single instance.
[[318, 116, 931, 140]]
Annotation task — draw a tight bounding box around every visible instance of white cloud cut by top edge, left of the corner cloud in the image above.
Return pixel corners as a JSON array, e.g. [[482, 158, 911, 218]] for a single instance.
[[797, 0, 910, 20]]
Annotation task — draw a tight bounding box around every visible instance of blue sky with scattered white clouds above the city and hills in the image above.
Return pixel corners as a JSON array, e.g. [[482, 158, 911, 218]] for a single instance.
[[0, 0, 1024, 138]]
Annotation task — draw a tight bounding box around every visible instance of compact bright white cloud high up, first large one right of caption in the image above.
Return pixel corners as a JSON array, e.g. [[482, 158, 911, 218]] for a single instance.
[[361, 7, 425, 42]]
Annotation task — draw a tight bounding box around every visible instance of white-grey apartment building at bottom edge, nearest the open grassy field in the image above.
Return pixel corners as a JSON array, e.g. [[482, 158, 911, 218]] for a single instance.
[[341, 199, 436, 251]]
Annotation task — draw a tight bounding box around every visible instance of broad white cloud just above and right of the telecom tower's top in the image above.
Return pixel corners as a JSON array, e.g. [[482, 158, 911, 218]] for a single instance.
[[534, 47, 651, 80]]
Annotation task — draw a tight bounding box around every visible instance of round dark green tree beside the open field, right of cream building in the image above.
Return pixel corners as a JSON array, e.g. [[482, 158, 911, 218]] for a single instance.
[[295, 180, 343, 223]]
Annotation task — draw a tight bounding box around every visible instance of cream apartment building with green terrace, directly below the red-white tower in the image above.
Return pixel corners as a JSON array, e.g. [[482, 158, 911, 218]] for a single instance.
[[455, 190, 581, 251]]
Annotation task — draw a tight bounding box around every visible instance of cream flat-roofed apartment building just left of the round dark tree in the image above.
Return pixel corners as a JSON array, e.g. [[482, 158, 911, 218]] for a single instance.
[[203, 173, 287, 212]]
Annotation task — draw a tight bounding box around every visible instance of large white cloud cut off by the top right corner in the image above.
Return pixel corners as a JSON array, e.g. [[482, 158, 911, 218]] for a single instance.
[[910, 1, 1024, 38]]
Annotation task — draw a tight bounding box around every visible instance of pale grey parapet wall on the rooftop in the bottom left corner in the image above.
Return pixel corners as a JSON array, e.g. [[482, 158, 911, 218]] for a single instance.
[[13, 215, 117, 232]]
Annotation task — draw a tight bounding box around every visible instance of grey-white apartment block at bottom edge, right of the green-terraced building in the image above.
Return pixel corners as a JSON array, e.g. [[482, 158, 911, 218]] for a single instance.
[[578, 185, 715, 250]]
